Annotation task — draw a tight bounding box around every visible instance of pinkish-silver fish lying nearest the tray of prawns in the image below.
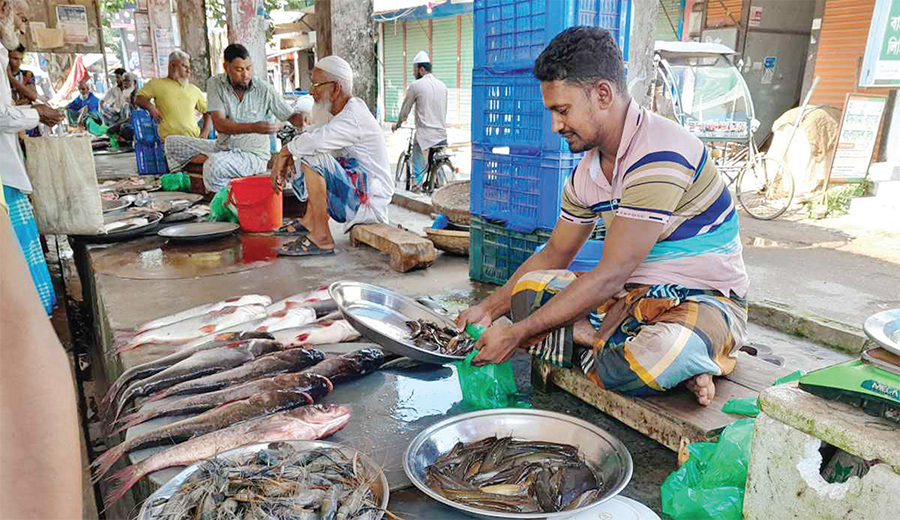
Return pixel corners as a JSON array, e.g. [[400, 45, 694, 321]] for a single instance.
[[105, 405, 350, 507]]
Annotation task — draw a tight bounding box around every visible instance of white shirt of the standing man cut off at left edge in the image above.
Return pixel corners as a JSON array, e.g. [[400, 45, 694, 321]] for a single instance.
[[0, 45, 40, 193]]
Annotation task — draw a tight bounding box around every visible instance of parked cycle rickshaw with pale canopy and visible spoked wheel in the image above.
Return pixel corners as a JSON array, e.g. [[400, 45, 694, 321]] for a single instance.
[[649, 41, 794, 220]]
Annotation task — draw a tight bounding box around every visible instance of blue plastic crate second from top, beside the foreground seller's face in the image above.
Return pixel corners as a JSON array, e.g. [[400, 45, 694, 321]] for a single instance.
[[471, 69, 569, 155]]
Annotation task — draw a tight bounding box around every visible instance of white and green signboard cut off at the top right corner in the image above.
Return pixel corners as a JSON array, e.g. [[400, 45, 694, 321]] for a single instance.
[[859, 0, 900, 87]]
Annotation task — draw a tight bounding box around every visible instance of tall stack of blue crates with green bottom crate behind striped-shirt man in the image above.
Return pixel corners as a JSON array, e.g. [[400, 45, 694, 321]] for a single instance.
[[469, 0, 631, 283]]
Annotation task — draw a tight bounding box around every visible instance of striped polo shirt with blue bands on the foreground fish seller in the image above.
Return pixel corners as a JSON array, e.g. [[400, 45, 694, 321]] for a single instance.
[[561, 100, 749, 298]]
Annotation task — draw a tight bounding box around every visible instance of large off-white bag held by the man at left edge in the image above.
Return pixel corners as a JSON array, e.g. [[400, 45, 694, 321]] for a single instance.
[[25, 136, 103, 235]]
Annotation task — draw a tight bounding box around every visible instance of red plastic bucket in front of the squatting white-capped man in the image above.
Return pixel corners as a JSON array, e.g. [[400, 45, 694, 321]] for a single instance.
[[228, 175, 282, 233]]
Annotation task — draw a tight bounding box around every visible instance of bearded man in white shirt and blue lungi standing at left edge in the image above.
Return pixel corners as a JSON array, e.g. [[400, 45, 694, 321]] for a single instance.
[[0, 0, 64, 314]]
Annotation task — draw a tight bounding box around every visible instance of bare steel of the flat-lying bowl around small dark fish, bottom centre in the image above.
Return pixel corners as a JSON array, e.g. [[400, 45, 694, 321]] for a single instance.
[[403, 408, 633, 519]]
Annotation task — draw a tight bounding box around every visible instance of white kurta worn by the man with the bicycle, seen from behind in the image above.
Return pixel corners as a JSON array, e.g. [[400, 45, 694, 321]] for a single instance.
[[398, 74, 447, 150]]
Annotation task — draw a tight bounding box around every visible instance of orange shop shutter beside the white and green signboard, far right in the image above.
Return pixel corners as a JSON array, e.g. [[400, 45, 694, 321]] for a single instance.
[[810, 0, 889, 109]]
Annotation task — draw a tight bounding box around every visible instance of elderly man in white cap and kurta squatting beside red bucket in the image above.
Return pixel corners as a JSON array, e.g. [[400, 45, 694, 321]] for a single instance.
[[272, 56, 394, 256]]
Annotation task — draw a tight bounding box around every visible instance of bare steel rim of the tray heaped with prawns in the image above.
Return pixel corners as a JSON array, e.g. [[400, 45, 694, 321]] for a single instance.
[[137, 441, 390, 520]]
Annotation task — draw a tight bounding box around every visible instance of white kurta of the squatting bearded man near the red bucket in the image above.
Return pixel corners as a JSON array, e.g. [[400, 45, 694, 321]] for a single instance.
[[288, 98, 394, 229]]
